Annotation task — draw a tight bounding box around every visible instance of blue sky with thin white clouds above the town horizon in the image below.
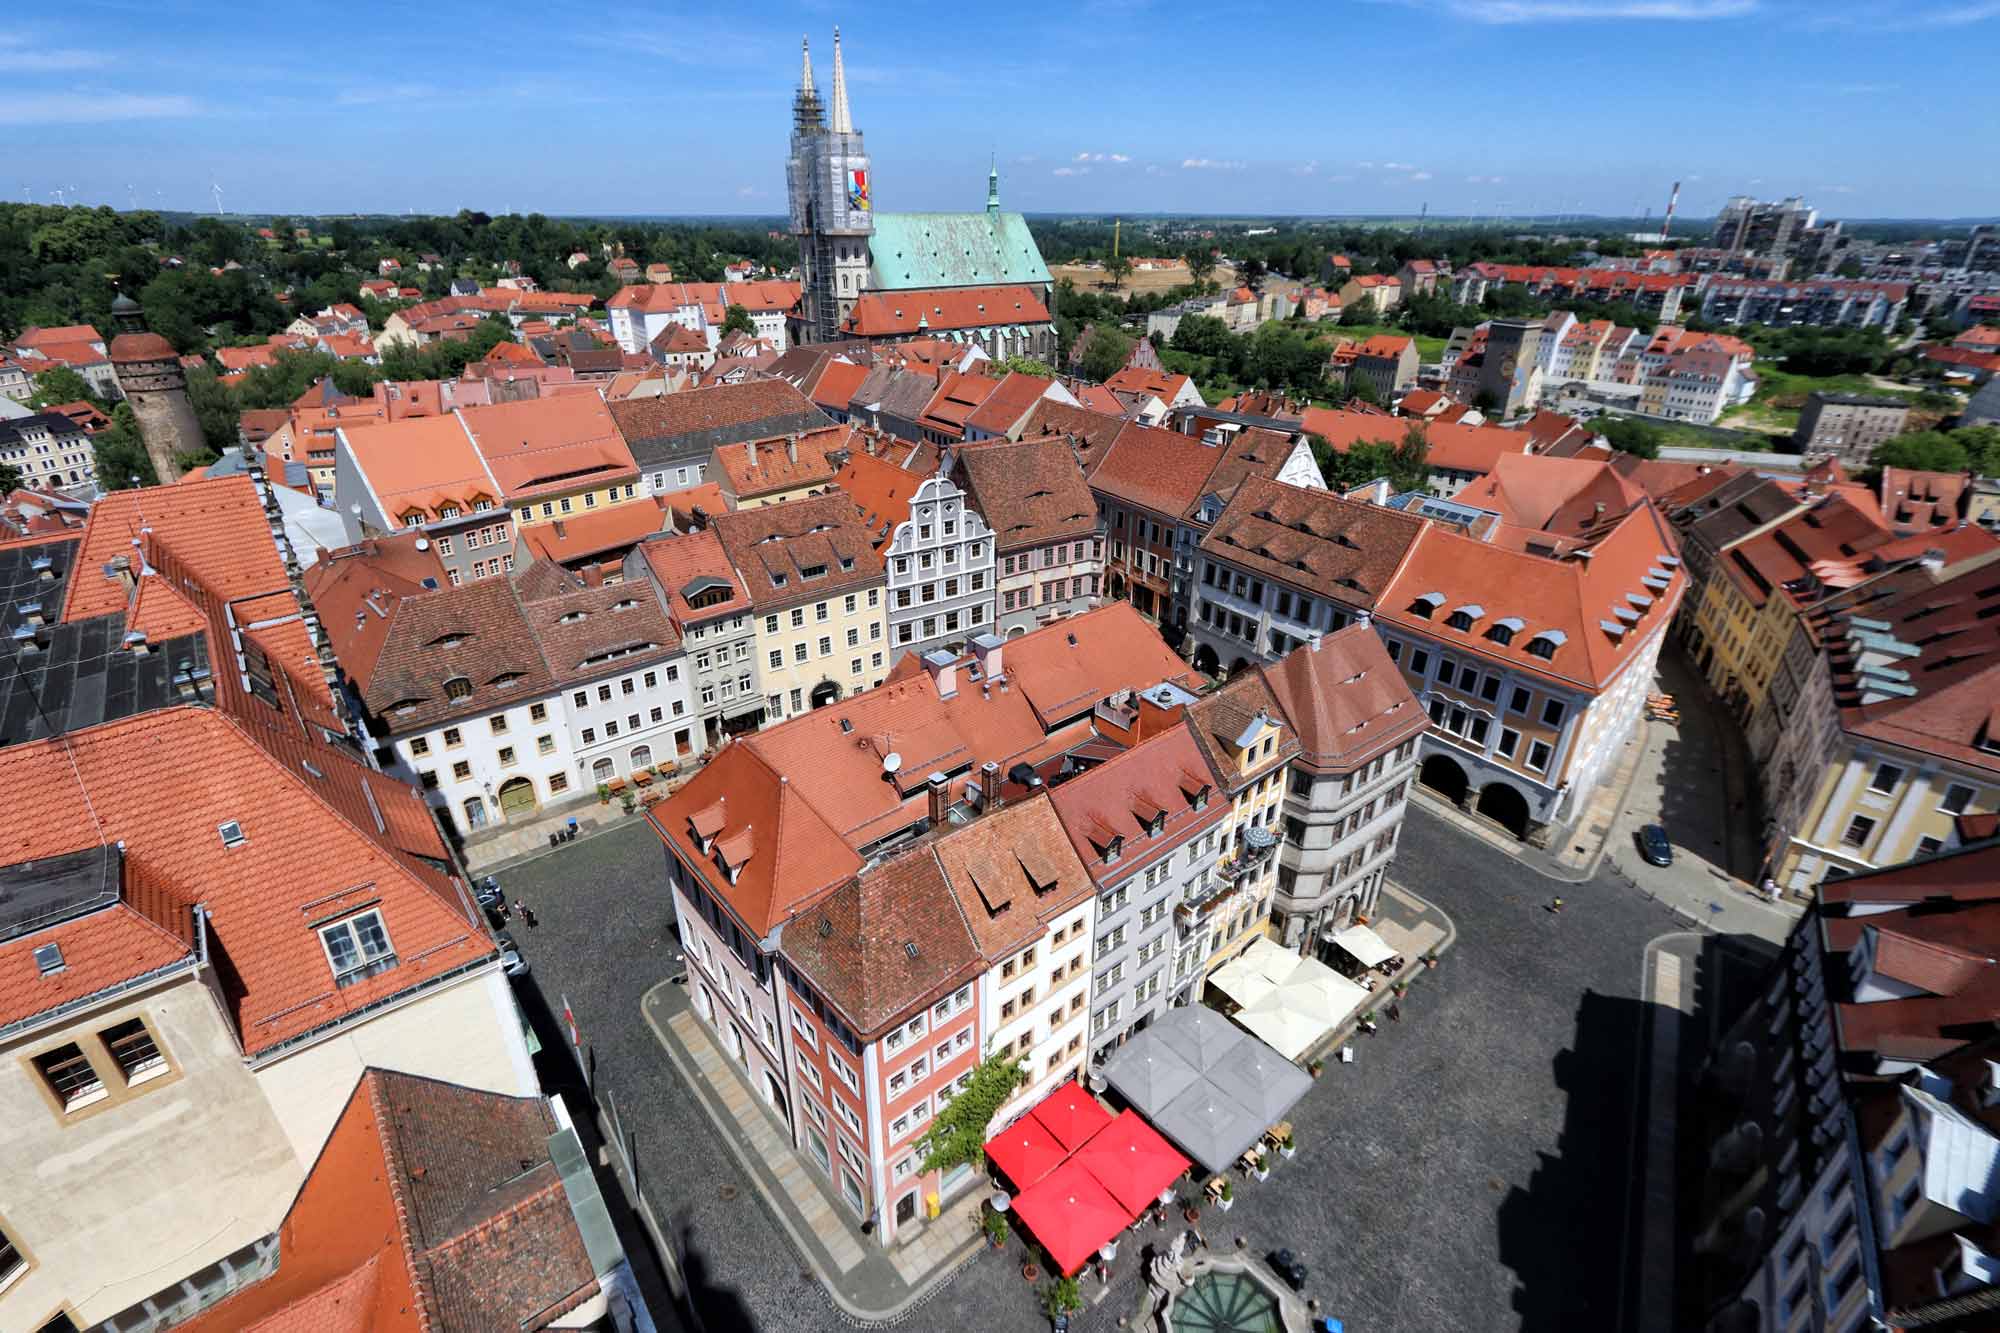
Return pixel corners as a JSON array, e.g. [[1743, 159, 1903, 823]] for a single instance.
[[0, 0, 2000, 218]]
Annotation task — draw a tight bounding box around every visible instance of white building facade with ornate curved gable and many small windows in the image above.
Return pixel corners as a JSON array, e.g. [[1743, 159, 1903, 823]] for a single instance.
[[880, 474, 994, 662]]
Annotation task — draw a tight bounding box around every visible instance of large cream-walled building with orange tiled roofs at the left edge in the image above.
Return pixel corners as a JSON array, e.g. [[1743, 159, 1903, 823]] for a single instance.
[[0, 476, 534, 1329]]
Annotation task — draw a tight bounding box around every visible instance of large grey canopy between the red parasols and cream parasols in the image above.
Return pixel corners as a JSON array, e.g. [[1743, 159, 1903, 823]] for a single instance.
[[1102, 1005, 1312, 1171]]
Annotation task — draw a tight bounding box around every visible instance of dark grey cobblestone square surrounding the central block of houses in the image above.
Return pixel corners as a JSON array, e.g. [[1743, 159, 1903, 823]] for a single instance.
[[502, 772, 1720, 1331]]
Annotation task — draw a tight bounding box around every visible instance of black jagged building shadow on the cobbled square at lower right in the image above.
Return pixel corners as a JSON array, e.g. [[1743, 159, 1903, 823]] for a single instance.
[[1498, 991, 1652, 1333]]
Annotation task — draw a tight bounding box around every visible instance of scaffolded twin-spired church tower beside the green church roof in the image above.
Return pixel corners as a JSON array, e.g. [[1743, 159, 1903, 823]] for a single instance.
[[786, 28, 874, 342]]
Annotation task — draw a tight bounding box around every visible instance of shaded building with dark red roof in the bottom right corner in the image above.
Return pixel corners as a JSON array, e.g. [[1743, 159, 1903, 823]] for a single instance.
[[1694, 837, 2000, 1333]]
